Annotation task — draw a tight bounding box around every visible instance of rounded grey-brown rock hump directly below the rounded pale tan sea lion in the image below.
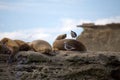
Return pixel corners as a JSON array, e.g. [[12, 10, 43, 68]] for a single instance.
[[15, 51, 50, 64]]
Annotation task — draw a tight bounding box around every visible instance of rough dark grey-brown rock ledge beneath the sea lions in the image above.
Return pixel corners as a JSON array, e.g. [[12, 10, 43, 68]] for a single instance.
[[0, 51, 120, 80]]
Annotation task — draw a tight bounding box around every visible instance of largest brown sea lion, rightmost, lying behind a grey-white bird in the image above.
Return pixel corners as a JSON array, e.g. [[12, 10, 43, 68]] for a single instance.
[[53, 39, 86, 51]]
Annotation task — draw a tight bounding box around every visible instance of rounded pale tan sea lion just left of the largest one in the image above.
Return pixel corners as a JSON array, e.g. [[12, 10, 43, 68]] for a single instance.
[[29, 40, 52, 54]]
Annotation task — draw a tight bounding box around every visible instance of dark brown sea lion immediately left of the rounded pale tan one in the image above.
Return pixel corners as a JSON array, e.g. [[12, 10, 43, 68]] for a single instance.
[[14, 40, 30, 51]]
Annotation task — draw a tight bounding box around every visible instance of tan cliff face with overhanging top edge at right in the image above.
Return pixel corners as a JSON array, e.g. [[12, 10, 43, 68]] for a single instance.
[[77, 23, 120, 52]]
